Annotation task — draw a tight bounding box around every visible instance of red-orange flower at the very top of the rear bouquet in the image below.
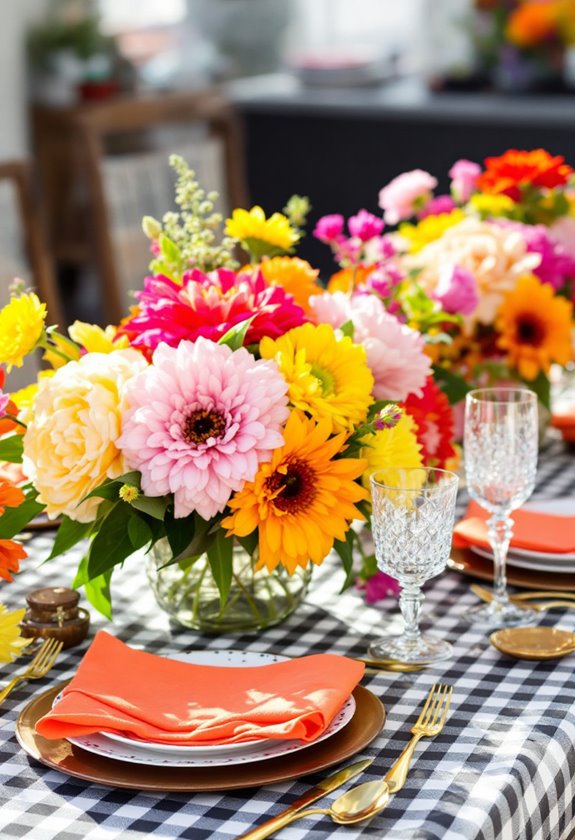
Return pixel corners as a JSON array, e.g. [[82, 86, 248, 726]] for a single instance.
[[477, 149, 573, 201]]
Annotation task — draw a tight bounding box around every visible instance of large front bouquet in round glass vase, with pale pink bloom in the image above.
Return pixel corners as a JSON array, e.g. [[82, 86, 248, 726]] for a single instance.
[[0, 158, 446, 629]]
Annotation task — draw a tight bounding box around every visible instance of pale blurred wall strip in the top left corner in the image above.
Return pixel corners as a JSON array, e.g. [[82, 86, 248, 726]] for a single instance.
[[0, 0, 49, 160]]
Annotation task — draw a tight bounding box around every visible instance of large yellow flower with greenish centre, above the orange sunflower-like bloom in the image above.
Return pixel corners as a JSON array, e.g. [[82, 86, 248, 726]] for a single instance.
[[260, 324, 373, 432]]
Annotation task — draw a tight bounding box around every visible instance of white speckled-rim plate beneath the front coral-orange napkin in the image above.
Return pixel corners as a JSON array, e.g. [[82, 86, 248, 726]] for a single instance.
[[59, 650, 355, 767]]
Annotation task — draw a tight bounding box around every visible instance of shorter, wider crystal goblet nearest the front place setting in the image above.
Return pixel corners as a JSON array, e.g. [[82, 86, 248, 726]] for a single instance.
[[369, 467, 459, 665]]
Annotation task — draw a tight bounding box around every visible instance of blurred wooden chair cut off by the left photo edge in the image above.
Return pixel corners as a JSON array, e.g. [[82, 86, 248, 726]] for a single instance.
[[0, 161, 64, 325]]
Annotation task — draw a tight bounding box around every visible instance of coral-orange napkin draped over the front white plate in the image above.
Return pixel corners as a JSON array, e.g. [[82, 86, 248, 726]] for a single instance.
[[36, 631, 364, 745]]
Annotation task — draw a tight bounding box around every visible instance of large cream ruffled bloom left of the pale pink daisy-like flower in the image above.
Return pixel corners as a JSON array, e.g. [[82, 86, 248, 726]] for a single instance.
[[23, 350, 147, 522]]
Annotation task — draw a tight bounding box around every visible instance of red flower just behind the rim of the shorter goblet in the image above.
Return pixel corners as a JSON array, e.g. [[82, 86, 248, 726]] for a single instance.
[[404, 376, 456, 469]]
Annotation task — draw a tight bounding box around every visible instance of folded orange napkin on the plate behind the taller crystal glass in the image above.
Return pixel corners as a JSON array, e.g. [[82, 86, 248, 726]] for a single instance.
[[453, 502, 575, 554]]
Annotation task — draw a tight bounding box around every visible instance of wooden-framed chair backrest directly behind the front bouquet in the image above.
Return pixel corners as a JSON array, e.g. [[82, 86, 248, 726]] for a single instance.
[[76, 91, 246, 323]]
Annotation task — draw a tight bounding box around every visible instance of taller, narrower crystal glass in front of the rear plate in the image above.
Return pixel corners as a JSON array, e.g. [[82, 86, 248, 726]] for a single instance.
[[464, 388, 539, 627]]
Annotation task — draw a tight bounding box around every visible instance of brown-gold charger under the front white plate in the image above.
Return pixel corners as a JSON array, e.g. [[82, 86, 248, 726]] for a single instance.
[[16, 680, 385, 793]]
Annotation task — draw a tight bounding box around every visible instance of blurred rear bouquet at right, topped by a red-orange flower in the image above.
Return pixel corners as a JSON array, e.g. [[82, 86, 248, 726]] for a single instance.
[[315, 149, 575, 434]]
